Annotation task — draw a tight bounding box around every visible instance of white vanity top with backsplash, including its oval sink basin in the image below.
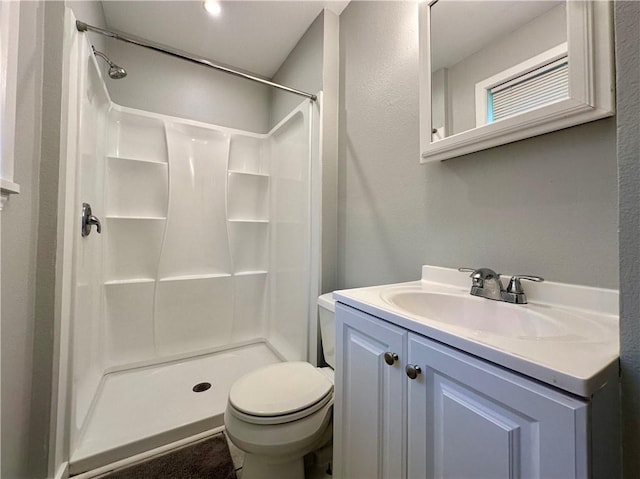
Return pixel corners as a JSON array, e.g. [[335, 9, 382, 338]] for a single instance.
[[333, 266, 620, 397]]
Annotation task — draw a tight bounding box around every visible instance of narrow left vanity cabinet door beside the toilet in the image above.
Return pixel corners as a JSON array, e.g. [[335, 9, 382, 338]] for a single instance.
[[333, 303, 407, 479]]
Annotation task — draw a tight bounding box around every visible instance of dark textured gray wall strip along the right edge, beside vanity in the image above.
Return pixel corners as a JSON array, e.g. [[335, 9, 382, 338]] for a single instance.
[[615, 2, 640, 478]]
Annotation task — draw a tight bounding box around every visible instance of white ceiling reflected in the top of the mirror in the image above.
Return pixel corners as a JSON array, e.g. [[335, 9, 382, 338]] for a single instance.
[[431, 0, 565, 71]]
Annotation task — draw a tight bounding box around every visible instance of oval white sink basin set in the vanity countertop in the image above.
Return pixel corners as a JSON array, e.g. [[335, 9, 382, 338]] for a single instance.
[[380, 290, 589, 341]]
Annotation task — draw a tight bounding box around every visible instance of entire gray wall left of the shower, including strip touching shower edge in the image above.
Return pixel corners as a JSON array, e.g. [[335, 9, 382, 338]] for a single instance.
[[0, 1, 64, 479]]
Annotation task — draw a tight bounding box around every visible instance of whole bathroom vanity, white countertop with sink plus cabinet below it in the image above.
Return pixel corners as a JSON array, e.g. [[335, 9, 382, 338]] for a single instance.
[[334, 266, 620, 479]]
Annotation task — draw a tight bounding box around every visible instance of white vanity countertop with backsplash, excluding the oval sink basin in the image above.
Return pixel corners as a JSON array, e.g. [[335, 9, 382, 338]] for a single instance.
[[334, 266, 619, 397]]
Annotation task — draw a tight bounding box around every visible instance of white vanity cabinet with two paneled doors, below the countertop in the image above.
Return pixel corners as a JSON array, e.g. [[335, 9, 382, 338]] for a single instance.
[[334, 303, 616, 479]]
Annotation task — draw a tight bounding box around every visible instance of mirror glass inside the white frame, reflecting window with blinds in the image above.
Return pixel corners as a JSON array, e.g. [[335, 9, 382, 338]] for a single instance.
[[430, 0, 569, 142]]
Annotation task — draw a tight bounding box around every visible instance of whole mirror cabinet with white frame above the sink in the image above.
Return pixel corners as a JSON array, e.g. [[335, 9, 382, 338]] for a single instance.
[[420, 0, 614, 162]]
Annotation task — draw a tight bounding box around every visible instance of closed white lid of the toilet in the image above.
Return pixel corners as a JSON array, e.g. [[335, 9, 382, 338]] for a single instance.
[[229, 361, 333, 416]]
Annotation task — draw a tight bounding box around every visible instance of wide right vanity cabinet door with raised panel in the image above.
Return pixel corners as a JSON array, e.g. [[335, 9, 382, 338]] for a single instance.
[[407, 334, 588, 479]]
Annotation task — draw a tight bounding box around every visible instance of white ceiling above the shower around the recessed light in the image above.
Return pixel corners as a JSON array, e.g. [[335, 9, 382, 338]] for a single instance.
[[102, 0, 349, 78]]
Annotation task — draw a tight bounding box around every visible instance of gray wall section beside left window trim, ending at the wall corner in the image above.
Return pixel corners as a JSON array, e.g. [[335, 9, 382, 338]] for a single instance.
[[0, 2, 44, 478]]
